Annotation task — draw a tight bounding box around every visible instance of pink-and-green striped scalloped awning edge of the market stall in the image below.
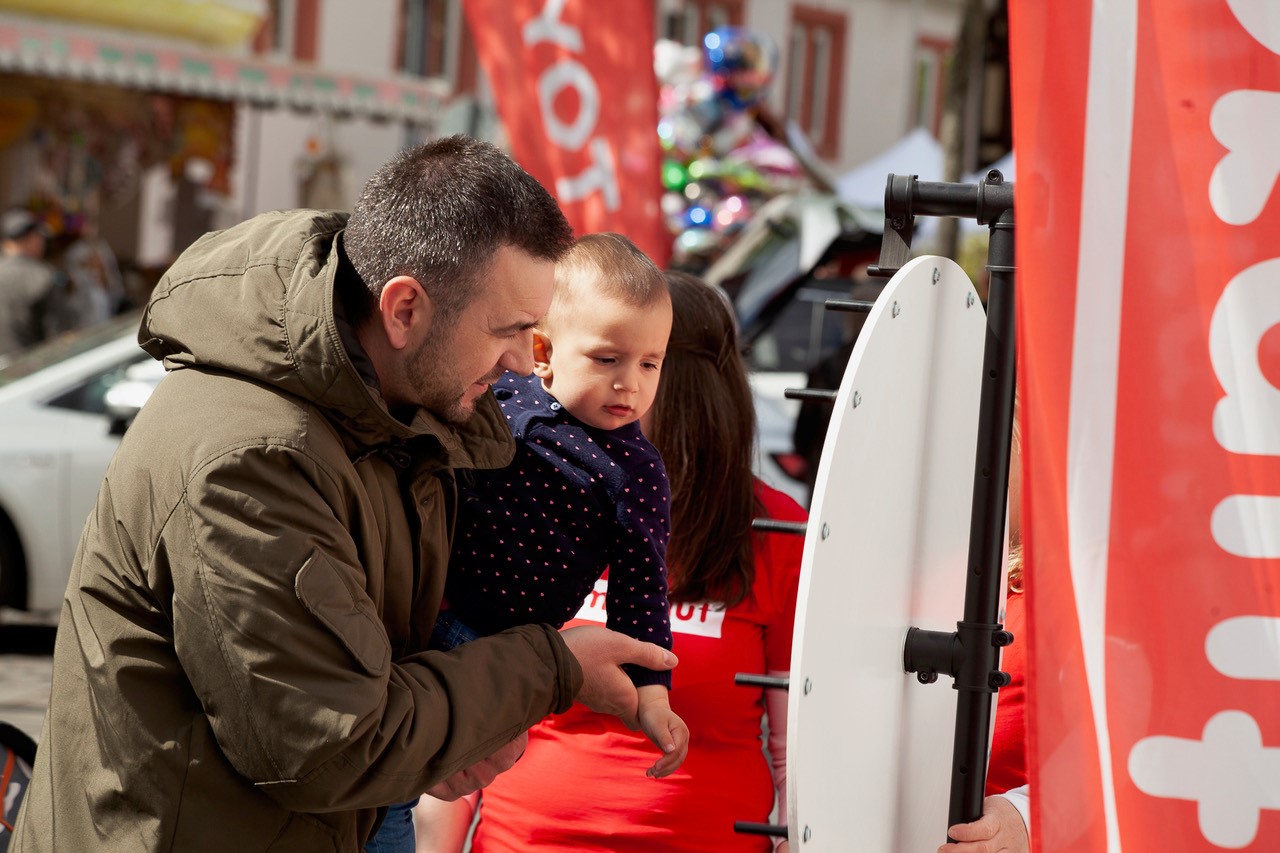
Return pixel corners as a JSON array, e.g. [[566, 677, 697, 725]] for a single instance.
[[0, 15, 449, 122]]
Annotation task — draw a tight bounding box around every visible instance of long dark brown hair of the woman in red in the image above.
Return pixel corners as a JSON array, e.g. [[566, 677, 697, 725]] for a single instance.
[[648, 272, 756, 607]]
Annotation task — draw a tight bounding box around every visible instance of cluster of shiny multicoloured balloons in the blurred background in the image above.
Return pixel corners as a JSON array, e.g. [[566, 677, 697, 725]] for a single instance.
[[654, 27, 804, 270]]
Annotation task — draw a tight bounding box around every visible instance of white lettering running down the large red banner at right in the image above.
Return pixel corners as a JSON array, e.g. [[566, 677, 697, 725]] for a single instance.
[[1129, 6, 1280, 848]]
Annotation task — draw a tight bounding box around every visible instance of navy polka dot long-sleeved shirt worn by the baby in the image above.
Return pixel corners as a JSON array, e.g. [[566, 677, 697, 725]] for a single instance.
[[445, 373, 671, 686]]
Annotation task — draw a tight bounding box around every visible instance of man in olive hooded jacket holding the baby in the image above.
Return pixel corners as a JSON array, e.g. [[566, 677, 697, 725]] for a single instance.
[[10, 137, 675, 853]]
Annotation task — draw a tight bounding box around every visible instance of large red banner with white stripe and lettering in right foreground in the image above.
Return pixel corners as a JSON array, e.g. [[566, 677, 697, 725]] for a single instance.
[[1009, 0, 1280, 853]]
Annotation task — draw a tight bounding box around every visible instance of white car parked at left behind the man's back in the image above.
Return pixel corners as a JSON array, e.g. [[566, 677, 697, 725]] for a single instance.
[[0, 314, 164, 622]]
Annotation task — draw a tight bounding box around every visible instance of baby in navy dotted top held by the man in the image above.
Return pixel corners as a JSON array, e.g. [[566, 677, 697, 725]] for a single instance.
[[433, 233, 689, 777]]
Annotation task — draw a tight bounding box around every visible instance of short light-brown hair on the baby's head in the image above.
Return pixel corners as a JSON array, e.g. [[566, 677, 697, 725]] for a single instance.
[[544, 232, 671, 324]]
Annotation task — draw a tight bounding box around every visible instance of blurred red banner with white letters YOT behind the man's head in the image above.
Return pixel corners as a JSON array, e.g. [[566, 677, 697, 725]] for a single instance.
[[465, 0, 671, 266]]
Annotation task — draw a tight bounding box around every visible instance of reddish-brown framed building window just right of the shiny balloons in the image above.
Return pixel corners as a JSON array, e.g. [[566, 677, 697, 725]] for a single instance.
[[786, 5, 849, 158]]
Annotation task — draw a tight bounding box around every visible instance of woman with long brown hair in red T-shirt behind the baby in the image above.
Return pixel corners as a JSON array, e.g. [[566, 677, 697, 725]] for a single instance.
[[417, 273, 805, 853]]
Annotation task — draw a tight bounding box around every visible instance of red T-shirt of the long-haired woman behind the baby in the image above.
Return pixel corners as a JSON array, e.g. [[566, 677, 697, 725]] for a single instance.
[[472, 485, 805, 853]]
